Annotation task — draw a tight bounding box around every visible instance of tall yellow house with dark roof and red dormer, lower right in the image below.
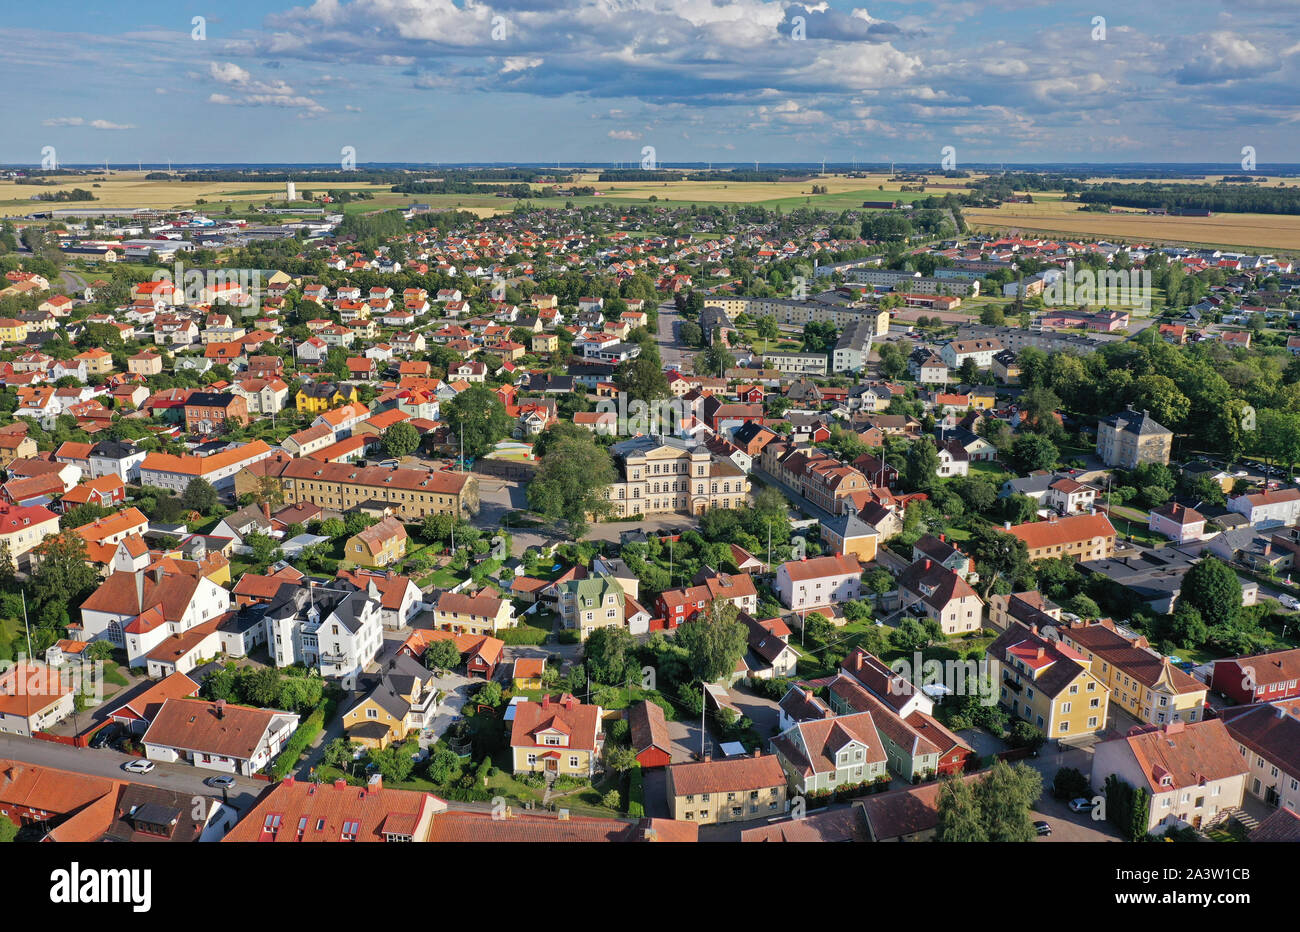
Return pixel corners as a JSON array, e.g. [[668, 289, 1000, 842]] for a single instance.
[[988, 621, 1110, 738]]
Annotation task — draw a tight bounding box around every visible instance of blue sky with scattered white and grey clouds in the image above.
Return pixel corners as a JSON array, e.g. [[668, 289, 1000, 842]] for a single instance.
[[0, 0, 1300, 168]]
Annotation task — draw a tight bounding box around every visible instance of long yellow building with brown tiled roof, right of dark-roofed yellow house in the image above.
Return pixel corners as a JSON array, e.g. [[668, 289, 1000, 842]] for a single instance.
[[1060, 619, 1209, 725]]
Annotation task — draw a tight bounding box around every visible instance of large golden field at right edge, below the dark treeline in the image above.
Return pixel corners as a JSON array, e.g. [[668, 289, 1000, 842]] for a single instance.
[[965, 195, 1300, 250]]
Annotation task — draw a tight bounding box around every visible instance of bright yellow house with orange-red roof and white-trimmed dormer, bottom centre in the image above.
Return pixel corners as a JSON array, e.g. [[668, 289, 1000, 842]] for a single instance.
[[510, 693, 601, 777]]
